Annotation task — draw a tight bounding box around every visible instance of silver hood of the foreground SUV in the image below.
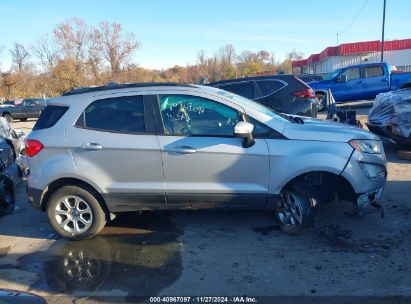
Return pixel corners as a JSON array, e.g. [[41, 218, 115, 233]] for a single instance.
[[283, 116, 379, 142]]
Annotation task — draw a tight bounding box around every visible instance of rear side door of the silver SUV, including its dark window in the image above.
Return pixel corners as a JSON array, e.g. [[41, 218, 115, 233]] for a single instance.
[[66, 93, 165, 211]]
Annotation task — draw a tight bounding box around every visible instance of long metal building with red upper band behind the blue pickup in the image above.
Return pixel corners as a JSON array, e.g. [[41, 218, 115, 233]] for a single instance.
[[292, 39, 411, 75]]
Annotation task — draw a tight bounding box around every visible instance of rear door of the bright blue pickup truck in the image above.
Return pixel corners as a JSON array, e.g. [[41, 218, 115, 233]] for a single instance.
[[364, 64, 390, 98]]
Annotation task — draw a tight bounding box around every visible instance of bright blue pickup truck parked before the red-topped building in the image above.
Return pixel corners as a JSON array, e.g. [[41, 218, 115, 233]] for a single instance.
[[309, 63, 411, 102]]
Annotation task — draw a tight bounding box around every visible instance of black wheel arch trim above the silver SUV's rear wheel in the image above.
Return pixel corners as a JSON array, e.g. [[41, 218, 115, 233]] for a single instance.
[[40, 177, 110, 214]]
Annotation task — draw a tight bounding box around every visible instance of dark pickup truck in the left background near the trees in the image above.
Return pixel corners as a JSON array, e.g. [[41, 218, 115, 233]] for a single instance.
[[0, 99, 47, 122]]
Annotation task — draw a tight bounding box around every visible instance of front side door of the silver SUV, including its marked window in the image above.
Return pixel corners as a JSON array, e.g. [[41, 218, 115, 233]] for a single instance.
[[154, 93, 269, 208]]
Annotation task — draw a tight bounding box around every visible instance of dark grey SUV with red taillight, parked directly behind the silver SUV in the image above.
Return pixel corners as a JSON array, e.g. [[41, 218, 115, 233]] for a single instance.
[[209, 74, 317, 117]]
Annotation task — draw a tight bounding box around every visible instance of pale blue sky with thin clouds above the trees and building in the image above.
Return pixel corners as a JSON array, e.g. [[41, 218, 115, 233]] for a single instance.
[[0, 0, 411, 68]]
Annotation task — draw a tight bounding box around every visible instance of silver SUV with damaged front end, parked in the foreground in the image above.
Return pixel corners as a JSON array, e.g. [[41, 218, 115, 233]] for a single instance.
[[26, 83, 386, 239]]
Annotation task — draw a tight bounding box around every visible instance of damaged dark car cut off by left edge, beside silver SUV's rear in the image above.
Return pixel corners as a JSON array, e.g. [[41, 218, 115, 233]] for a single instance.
[[0, 117, 24, 216]]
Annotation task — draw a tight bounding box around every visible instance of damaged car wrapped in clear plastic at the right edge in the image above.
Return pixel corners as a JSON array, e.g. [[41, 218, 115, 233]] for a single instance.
[[367, 88, 411, 146]]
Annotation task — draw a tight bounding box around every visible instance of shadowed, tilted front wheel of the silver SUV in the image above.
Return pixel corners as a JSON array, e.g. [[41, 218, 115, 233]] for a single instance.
[[276, 188, 312, 234]]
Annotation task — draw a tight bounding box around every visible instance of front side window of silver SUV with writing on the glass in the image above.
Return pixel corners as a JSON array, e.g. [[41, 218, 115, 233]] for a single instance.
[[159, 95, 241, 137]]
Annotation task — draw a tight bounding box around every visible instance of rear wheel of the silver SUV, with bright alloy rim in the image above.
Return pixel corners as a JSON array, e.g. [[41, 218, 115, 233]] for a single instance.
[[47, 186, 106, 240]]
